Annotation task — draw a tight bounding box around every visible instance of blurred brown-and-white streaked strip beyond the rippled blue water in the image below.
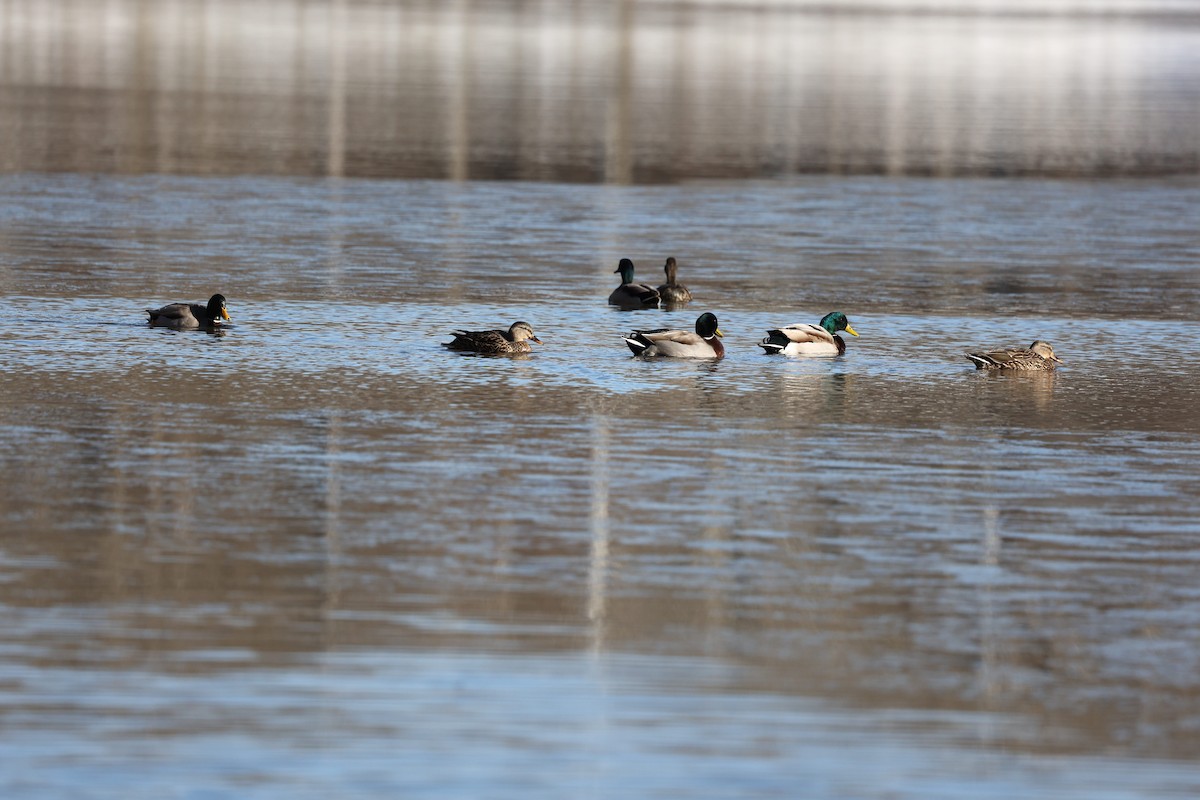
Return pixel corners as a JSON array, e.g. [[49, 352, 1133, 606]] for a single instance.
[[0, 0, 1200, 184]]
